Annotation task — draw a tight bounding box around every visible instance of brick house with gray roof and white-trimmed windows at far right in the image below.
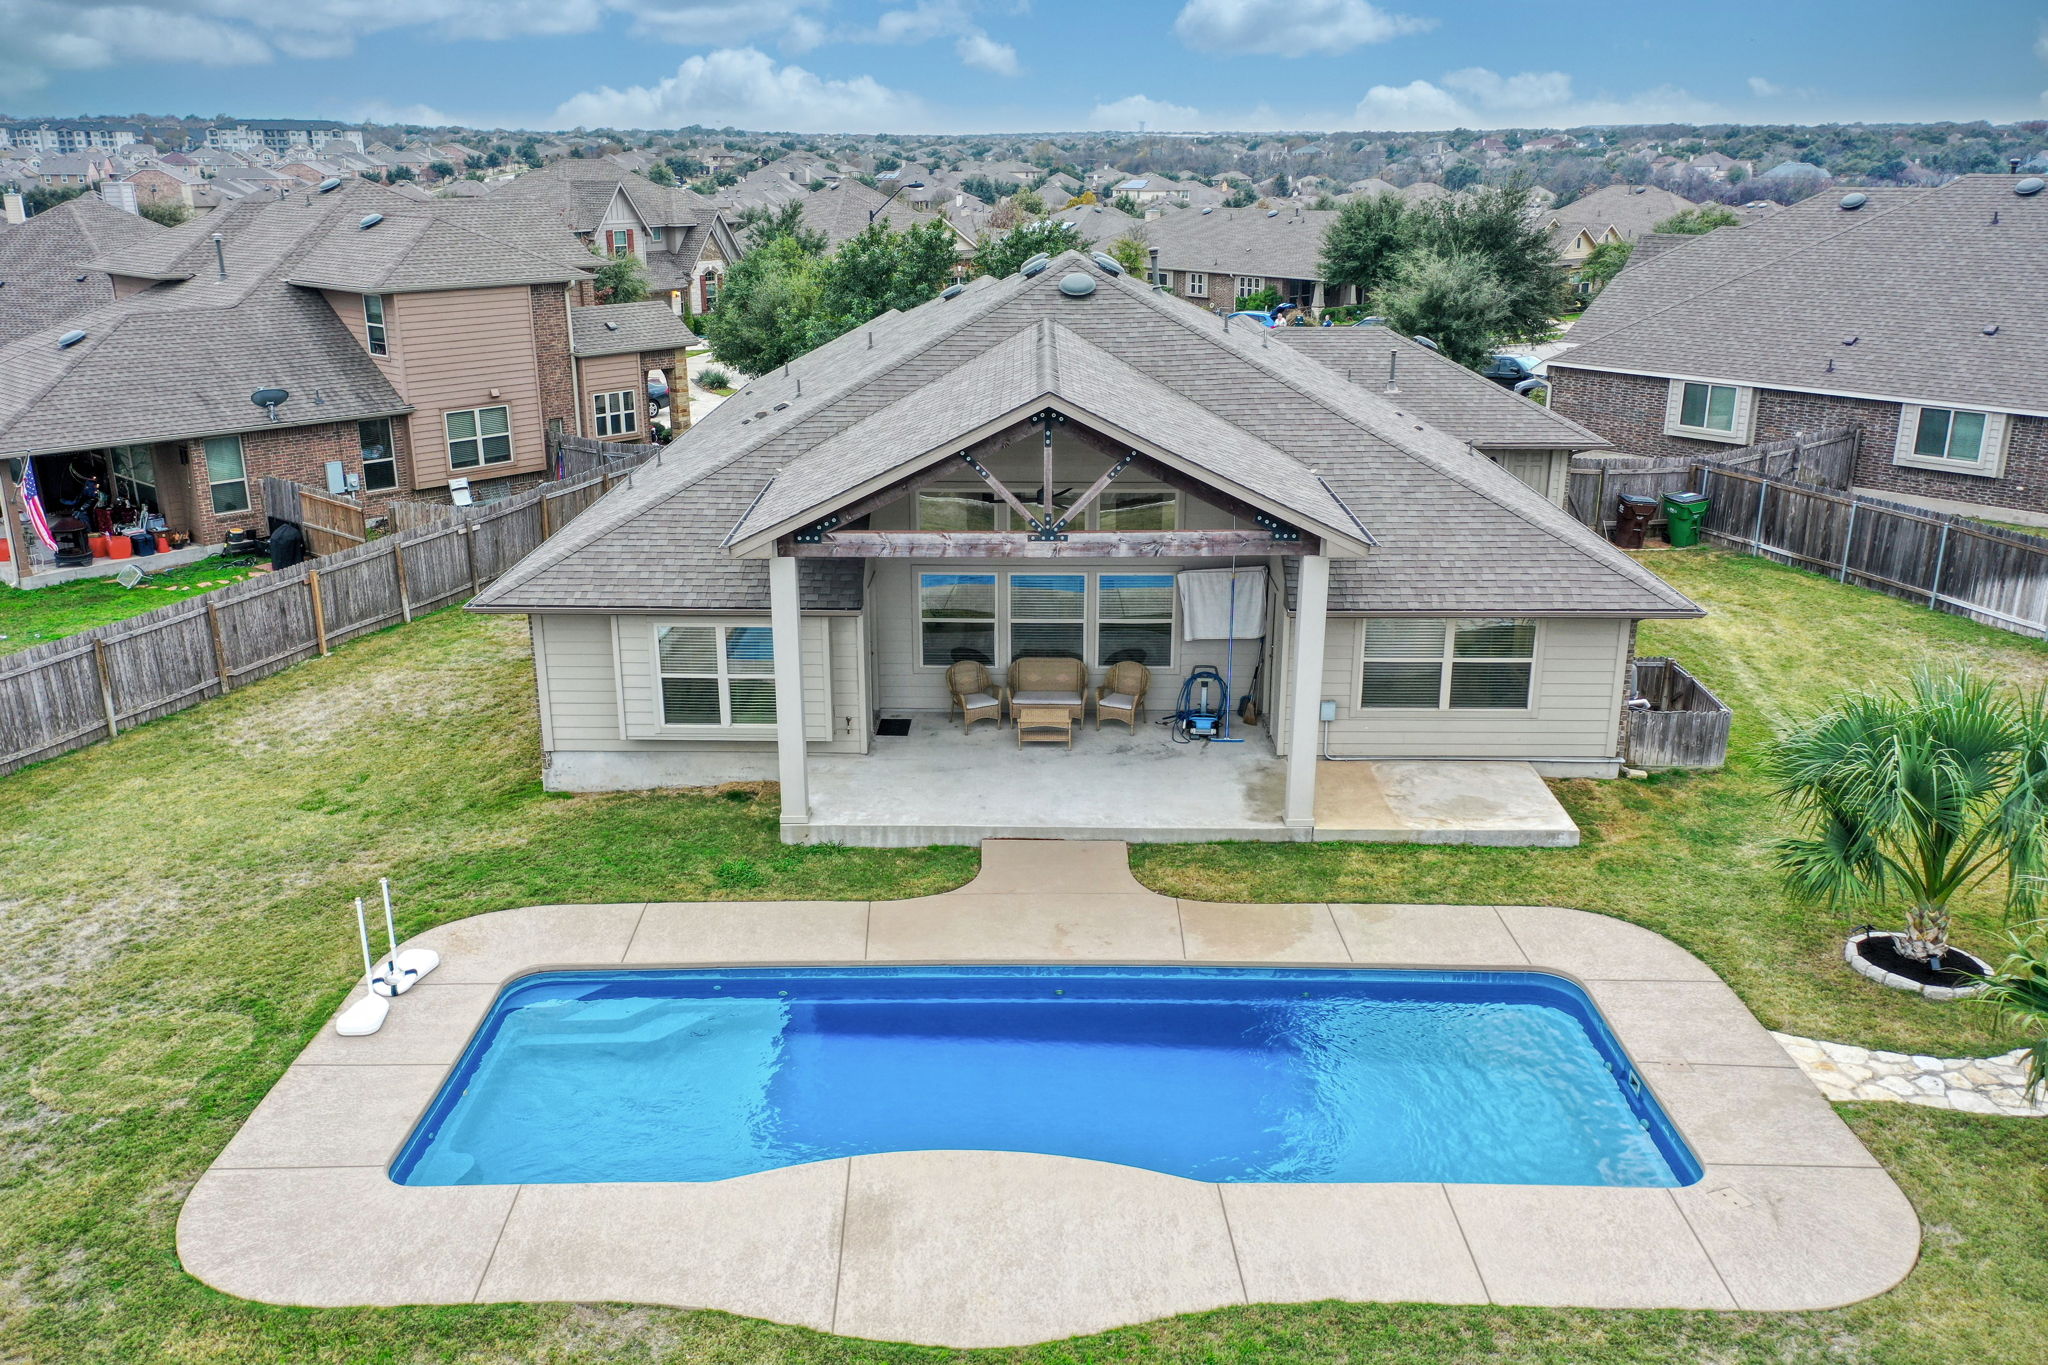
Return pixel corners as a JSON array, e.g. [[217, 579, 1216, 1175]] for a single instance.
[[1550, 176, 2048, 524]]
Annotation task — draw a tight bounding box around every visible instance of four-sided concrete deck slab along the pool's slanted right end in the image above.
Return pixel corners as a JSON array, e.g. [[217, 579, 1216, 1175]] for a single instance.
[[1638, 1062, 1878, 1166]]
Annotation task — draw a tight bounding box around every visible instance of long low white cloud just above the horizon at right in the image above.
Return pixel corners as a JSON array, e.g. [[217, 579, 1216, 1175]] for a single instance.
[[1352, 68, 1718, 131]]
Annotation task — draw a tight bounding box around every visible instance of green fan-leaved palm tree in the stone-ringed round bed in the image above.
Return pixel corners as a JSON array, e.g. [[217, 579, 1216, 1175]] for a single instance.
[[1772, 673, 2048, 970]]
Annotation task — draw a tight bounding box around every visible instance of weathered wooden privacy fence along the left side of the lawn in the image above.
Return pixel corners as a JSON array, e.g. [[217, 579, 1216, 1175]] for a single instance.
[[0, 458, 651, 774]]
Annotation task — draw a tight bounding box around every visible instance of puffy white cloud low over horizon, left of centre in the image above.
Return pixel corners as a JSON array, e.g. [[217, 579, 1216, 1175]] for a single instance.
[[555, 47, 924, 133]]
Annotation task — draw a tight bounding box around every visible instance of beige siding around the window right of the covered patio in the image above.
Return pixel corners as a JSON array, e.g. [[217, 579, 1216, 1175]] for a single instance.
[[1268, 616, 1628, 759]]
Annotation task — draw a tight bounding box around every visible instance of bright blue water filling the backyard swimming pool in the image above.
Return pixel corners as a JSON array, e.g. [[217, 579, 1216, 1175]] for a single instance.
[[391, 966, 1700, 1185]]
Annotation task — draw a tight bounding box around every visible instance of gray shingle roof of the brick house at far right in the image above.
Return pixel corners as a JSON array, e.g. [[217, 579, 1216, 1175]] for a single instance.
[[1552, 176, 2048, 413]]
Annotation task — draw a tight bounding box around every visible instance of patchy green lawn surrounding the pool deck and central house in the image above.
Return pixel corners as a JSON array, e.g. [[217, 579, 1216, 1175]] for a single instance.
[[0, 553, 2048, 1365]]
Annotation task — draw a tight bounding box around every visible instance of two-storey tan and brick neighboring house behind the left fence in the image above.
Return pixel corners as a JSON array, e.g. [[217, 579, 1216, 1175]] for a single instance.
[[0, 182, 634, 564]]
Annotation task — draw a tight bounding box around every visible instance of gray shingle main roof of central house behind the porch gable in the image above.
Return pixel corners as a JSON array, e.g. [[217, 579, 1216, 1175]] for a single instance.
[[475, 254, 1698, 616]]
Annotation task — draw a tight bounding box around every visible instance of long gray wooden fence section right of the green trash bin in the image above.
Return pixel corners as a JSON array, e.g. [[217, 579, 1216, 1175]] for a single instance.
[[1698, 465, 2048, 639]]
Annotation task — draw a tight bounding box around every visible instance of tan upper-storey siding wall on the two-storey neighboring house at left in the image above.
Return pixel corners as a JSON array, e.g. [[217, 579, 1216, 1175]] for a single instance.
[[387, 287, 547, 489]]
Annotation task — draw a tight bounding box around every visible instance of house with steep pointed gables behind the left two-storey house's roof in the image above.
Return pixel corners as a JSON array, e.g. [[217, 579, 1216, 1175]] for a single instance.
[[489, 158, 739, 313]]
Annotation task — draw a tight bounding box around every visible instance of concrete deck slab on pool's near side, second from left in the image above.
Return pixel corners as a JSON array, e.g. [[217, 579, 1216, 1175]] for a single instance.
[[477, 1160, 848, 1330]]
